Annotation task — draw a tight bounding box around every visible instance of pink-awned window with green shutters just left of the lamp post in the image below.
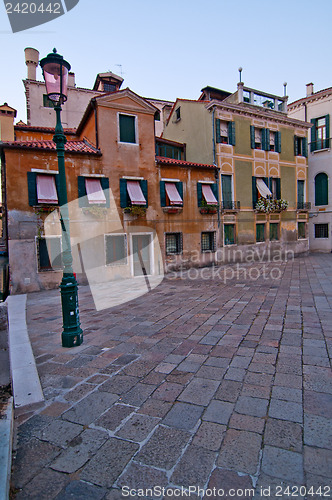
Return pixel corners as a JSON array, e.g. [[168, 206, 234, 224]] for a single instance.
[[27, 172, 59, 207]]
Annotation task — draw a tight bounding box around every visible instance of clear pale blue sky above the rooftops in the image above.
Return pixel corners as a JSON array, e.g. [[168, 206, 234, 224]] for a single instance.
[[0, 0, 332, 121]]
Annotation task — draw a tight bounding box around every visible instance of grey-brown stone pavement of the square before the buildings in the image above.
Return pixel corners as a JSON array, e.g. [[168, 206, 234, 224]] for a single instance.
[[12, 254, 332, 500]]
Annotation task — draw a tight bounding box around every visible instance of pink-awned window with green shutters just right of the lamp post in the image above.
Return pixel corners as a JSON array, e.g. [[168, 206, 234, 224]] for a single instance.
[[77, 175, 110, 208]]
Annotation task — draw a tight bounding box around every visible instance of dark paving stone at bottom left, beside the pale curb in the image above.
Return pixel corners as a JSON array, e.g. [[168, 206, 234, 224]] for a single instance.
[[12, 438, 61, 488]]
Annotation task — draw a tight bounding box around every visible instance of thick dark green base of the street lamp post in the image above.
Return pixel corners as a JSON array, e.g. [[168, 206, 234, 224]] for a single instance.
[[60, 273, 83, 347]]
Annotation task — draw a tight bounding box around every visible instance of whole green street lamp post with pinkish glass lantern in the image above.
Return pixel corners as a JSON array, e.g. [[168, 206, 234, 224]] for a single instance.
[[40, 49, 83, 347]]
